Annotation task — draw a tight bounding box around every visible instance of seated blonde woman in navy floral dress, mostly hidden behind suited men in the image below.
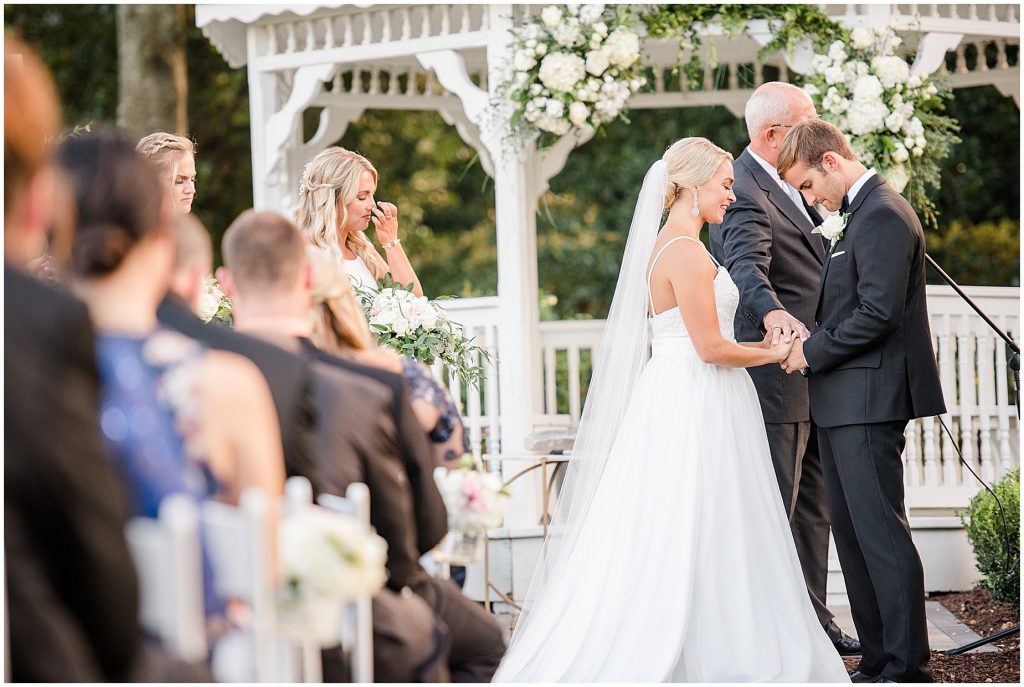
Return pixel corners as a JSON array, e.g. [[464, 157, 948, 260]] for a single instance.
[[306, 248, 469, 466]]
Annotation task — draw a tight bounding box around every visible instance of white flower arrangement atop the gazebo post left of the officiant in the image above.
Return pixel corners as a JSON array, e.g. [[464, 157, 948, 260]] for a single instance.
[[499, 4, 645, 146]]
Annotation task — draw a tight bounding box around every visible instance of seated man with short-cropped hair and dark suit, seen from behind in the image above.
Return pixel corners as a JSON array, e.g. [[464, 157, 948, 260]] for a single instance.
[[220, 212, 505, 682]]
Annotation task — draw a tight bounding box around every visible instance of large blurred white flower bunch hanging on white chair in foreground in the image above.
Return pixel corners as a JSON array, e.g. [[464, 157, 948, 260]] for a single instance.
[[278, 507, 387, 645]]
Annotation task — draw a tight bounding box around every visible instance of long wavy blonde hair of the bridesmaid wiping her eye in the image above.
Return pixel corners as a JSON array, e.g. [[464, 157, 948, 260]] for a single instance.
[[295, 145, 388, 280]]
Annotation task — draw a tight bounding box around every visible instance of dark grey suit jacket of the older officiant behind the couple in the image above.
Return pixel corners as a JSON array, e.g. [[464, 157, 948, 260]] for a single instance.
[[709, 151, 825, 423]]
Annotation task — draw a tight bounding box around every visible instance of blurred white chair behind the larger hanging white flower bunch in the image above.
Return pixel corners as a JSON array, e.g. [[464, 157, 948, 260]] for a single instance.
[[305, 477, 374, 682]]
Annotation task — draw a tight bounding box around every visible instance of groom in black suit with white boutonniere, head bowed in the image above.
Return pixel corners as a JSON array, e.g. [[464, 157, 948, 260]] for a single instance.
[[777, 120, 945, 682]]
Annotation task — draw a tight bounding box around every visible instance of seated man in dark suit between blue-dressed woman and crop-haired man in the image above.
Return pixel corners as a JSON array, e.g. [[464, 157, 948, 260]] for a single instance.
[[157, 214, 314, 487]]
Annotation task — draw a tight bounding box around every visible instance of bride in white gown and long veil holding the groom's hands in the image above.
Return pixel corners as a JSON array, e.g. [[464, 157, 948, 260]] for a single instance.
[[495, 138, 849, 682]]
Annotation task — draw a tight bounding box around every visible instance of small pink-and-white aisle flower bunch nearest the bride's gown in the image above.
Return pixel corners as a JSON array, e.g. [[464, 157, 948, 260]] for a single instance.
[[434, 454, 509, 534]]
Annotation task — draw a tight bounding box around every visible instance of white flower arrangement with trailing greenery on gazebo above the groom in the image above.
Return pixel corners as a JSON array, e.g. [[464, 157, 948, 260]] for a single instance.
[[804, 27, 959, 223]]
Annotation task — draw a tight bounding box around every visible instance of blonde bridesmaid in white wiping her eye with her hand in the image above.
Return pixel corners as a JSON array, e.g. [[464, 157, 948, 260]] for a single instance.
[[295, 145, 423, 296]]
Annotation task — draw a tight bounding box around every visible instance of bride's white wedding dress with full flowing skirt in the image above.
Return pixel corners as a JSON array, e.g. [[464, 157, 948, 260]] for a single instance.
[[495, 235, 849, 682]]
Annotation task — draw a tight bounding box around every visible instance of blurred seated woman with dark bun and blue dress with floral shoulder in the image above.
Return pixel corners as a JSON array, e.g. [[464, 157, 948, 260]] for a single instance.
[[57, 130, 284, 617]]
